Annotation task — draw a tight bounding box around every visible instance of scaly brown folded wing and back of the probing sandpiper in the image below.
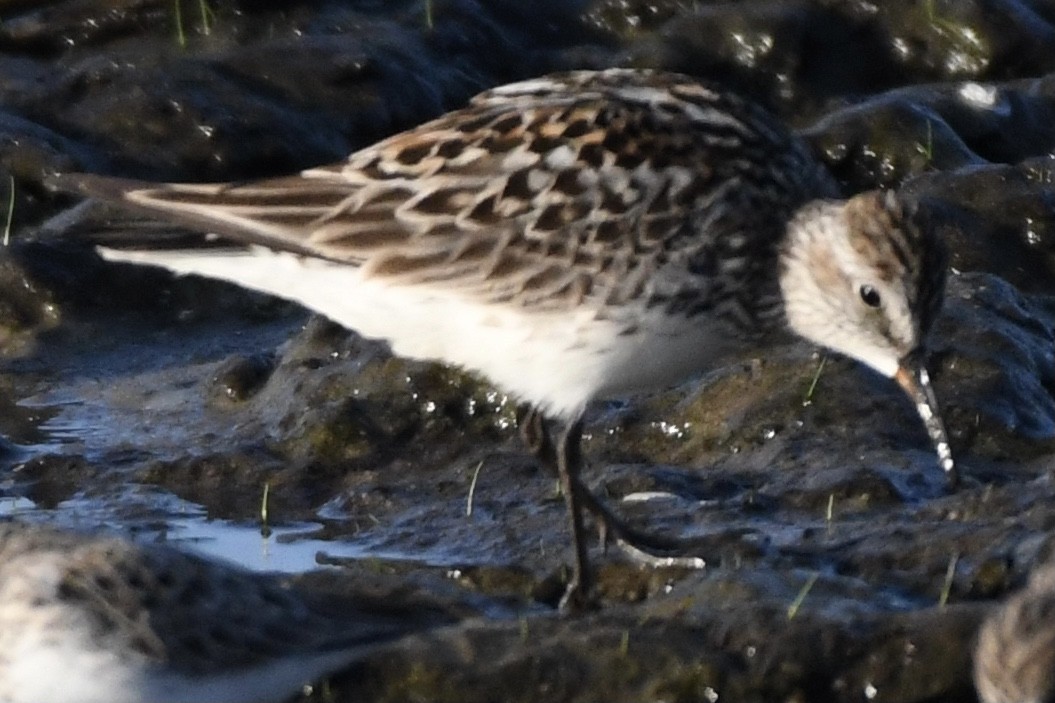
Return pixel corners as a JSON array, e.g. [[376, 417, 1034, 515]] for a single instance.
[[49, 71, 795, 303]]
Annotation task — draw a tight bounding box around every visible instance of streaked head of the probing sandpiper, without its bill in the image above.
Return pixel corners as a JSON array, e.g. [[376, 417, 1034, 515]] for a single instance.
[[781, 191, 946, 377]]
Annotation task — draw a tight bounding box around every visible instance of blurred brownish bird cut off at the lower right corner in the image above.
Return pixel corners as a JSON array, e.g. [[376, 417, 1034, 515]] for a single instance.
[[974, 564, 1055, 703]]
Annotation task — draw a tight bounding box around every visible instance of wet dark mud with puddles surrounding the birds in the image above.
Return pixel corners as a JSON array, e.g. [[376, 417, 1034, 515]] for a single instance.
[[0, 0, 1055, 703]]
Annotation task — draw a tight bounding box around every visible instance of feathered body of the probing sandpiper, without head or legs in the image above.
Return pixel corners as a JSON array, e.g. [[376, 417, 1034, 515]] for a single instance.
[[53, 70, 881, 419]]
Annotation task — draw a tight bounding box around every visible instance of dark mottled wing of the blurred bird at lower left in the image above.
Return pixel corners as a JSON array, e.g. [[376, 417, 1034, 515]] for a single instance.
[[60, 539, 441, 676]]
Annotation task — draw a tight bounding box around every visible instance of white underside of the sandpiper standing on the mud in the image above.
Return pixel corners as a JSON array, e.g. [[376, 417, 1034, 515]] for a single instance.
[[103, 249, 728, 418]]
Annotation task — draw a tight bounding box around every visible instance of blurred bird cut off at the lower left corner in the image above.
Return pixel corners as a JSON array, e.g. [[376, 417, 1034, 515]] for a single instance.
[[0, 521, 446, 703]]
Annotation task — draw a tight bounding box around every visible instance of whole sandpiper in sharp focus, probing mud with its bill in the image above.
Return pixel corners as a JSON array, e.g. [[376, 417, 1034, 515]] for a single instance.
[[47, 69, 956, 609]]
